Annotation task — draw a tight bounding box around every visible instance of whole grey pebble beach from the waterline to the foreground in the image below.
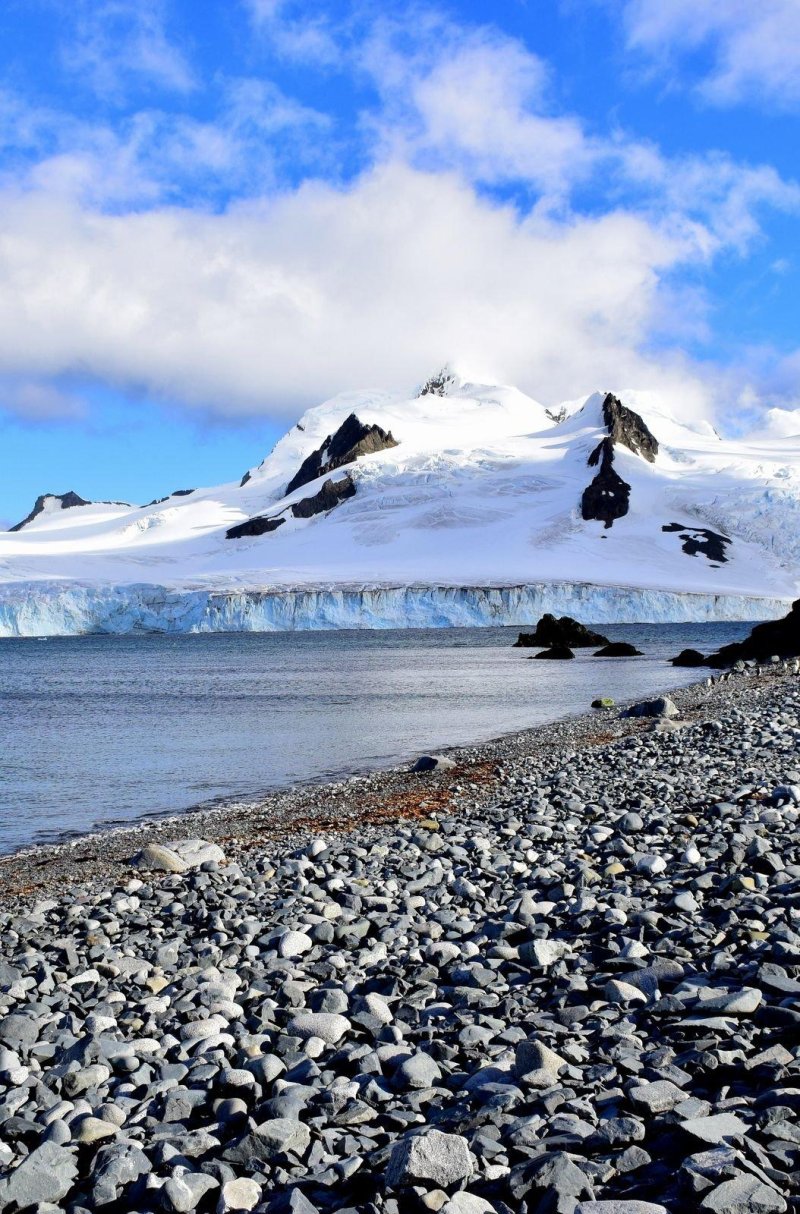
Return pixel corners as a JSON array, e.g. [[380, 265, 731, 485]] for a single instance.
[[0, 664, 800, 1214]]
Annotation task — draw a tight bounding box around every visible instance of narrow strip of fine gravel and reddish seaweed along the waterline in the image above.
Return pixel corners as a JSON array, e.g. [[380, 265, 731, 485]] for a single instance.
[[0, 668, 788, 906]]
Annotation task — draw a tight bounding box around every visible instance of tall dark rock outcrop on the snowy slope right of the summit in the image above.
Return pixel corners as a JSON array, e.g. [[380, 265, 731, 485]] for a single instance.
[[580, 392, 658, 528]]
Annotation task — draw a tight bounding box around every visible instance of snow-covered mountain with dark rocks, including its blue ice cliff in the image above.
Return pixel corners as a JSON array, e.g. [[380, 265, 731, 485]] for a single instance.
[[0, 374, 800, 635]]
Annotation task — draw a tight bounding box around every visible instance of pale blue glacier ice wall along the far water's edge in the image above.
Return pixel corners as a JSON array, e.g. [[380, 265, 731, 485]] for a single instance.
[[0, 582, 788, 637]]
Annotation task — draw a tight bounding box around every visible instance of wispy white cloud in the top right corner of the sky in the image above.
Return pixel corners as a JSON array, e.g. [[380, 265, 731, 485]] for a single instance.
[[614, 0, 800, 106]]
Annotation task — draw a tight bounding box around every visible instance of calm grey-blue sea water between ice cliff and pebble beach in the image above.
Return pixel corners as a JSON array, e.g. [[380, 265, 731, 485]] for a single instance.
[[0, 623, 751, 853]]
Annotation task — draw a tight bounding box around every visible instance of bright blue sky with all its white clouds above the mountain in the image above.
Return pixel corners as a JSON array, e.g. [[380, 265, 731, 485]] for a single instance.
[[0, 0, 800, 523]]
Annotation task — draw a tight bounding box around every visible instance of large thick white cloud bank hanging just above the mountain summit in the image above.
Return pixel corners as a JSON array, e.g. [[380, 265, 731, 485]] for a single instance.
[[0, 164, 696, 416]]
